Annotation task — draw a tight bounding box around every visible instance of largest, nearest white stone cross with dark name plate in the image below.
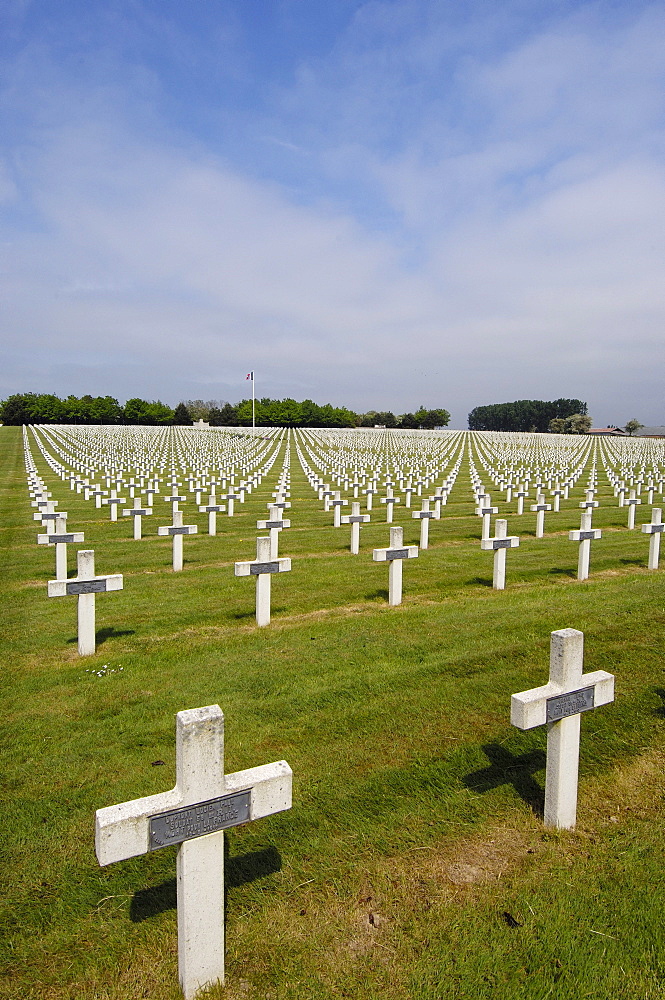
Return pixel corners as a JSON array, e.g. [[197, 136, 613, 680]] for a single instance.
[[95, 705, 292, 1000]]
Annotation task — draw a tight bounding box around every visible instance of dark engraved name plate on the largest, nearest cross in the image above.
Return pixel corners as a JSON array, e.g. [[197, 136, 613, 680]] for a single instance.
[[149, 788, 252, 851]]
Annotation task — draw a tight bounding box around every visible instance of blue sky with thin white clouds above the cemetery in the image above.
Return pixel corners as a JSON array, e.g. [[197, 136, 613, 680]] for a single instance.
[[0, 0, 665, 427]]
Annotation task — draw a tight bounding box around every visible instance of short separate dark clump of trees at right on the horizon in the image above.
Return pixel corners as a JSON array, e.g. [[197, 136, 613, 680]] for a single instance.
[[469, 399, 591, 434]]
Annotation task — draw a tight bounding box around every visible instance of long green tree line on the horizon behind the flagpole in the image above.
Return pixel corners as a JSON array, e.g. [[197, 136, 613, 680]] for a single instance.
[[0, 392, 450, 428]]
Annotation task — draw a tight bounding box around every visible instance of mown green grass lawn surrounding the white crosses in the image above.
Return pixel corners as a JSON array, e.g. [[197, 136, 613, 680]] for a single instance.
[[0, 428, 665, 1000]]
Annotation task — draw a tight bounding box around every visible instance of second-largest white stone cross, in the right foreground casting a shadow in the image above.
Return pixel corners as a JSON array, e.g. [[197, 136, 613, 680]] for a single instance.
[[510, 628, 614, 830]]
